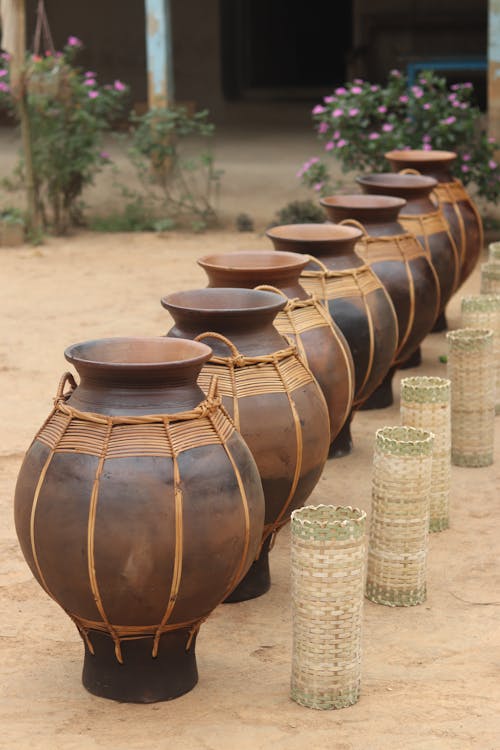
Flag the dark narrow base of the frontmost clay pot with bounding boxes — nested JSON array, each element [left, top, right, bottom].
[[82, 628, 198, 703]]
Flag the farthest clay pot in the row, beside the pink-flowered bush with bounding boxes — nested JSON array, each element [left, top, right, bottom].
[[385, 150, 484, 284]]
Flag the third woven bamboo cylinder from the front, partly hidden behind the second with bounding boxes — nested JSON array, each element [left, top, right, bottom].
[[401, 376, 451, 531]]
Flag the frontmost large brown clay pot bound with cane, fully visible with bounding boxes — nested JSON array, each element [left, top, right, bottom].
[[15, 338, 264, 703]]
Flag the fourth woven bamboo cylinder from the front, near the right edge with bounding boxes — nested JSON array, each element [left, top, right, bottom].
[[446, 328, 495, 467]]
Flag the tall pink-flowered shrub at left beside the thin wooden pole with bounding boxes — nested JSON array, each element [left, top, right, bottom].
[[0, 36, 127, 234]]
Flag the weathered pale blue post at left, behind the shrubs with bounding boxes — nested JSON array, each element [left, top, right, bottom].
[[145, 0, 174, 109]]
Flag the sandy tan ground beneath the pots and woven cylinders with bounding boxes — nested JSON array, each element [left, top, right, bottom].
[[0, 232, 500, 750]]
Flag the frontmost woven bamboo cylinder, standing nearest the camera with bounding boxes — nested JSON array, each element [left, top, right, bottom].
[[291, 505, 366, 709]]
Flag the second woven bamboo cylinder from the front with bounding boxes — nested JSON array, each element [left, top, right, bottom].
[[366, 427, 434, 607]]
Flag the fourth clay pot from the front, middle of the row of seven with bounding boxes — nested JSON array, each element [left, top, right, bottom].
[[267, 224, 398, 453]]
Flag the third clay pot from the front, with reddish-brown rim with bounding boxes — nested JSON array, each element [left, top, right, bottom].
[[198, 250, 354, 450]]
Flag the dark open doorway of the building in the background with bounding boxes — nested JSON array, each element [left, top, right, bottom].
[[221, 0, 352, 99]]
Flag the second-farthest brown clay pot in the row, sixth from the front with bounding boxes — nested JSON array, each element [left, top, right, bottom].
[[358, 172, 460, 331]]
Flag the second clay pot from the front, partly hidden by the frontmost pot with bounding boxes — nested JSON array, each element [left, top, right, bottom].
[[162, 288, 330, 601]]
